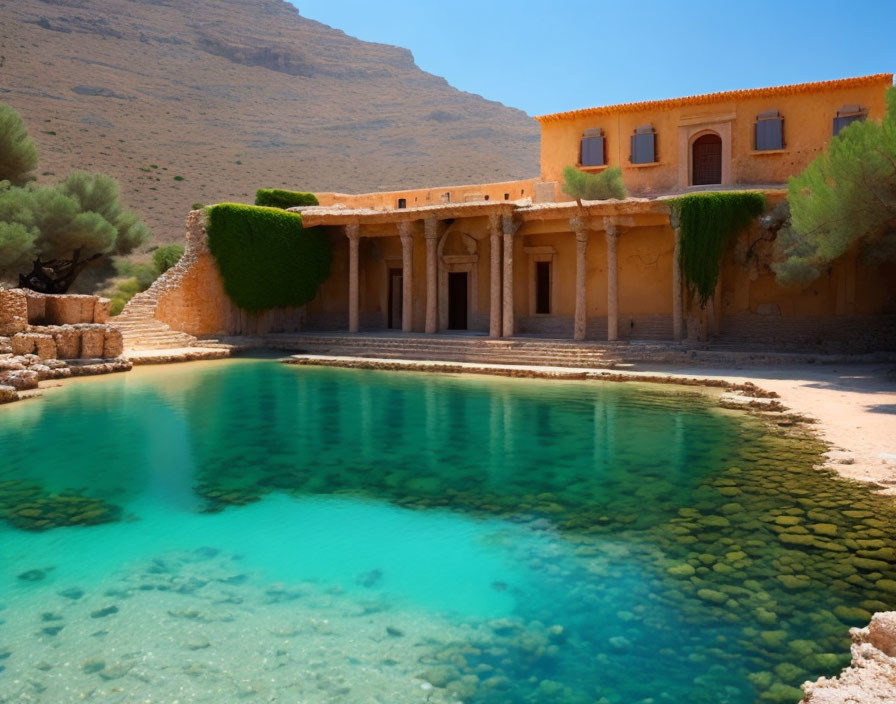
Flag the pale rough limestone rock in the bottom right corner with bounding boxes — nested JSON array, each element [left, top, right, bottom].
[[801, 611, 896, 704]]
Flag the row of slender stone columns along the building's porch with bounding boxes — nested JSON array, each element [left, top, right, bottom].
[[345, 214, 683, 340]]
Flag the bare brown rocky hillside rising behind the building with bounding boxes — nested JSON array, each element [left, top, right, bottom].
[[0, 0, 538, 242]]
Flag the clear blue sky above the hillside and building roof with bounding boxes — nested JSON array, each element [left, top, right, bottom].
[[291, 0, 896, 115]]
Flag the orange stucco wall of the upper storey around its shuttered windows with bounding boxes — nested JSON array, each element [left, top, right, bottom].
[[539, 74, 892, 200]]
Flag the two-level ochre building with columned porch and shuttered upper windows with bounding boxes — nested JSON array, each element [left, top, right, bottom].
[[149, 74, 896, 347]]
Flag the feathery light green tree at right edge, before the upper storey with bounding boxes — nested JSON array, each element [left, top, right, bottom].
[[772, 88, 896, 284]]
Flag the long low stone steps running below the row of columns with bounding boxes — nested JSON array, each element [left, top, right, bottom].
[[213, 334, 632, 369]]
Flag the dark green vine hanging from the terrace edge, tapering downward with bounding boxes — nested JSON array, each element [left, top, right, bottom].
[[670, 191, 765, 306]]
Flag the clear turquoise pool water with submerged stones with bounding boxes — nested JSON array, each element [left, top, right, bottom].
[[0, 359, 896, 704]]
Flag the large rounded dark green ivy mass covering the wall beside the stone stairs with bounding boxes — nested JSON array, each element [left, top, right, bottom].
[[207, 203, 332, 311]]
